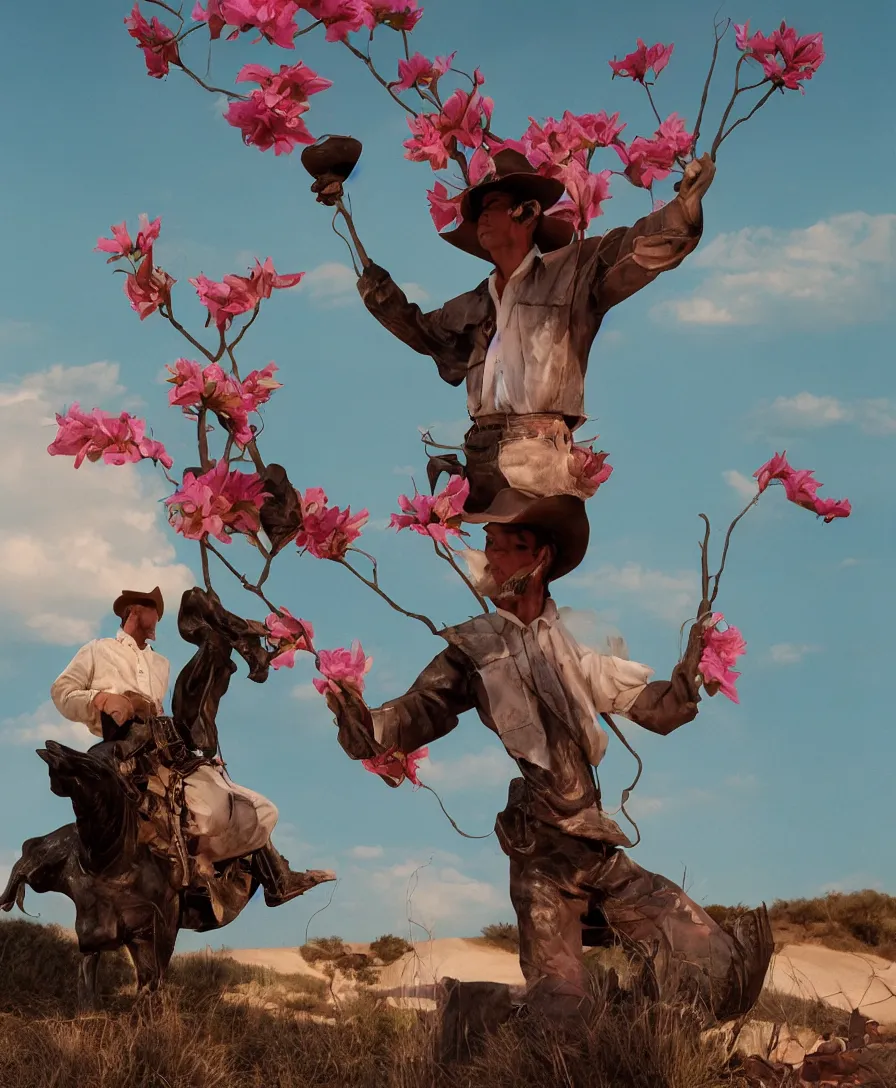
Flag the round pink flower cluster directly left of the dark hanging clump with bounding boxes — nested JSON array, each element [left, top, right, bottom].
[[165, 459, 267, 544]]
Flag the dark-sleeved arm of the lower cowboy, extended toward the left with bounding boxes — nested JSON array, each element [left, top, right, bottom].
[[329, 646, 475, 759]]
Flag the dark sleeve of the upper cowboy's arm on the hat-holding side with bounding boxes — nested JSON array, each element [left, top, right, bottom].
[[358, 264, 490, 385]]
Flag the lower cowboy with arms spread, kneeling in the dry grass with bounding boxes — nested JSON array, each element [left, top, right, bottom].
[[329, 496, 773, 1019]]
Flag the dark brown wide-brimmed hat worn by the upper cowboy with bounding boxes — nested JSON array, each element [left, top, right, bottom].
[[441, 148, 575, 261]]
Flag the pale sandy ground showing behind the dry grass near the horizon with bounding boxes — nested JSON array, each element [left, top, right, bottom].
[[226, 937, 896, 1024]]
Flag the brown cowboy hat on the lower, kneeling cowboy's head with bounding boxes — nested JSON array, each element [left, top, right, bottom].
[[462, 487, 590, 581]]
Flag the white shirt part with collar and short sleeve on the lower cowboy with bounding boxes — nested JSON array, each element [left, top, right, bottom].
[[497, 598, 654, 766]]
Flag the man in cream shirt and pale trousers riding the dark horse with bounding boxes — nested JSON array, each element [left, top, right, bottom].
[[50, 586, 335, 906]]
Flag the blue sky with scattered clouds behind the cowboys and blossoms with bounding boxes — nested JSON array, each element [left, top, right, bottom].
[[0, 0, 896, 948]]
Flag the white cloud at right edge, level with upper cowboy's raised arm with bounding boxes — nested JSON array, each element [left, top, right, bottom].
[[655, 211, 896, 325]]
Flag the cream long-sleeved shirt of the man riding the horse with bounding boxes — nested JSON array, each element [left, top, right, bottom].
[[50, 631, 171, 737]]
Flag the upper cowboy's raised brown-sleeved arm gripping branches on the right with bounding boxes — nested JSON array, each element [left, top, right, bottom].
[[592, 156, 715, 313]]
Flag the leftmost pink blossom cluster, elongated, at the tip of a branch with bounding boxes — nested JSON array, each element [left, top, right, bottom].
[[47, 403, 173, 469]]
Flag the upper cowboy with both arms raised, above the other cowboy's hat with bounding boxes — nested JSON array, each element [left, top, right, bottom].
[[358, 149, 715, 521]]
